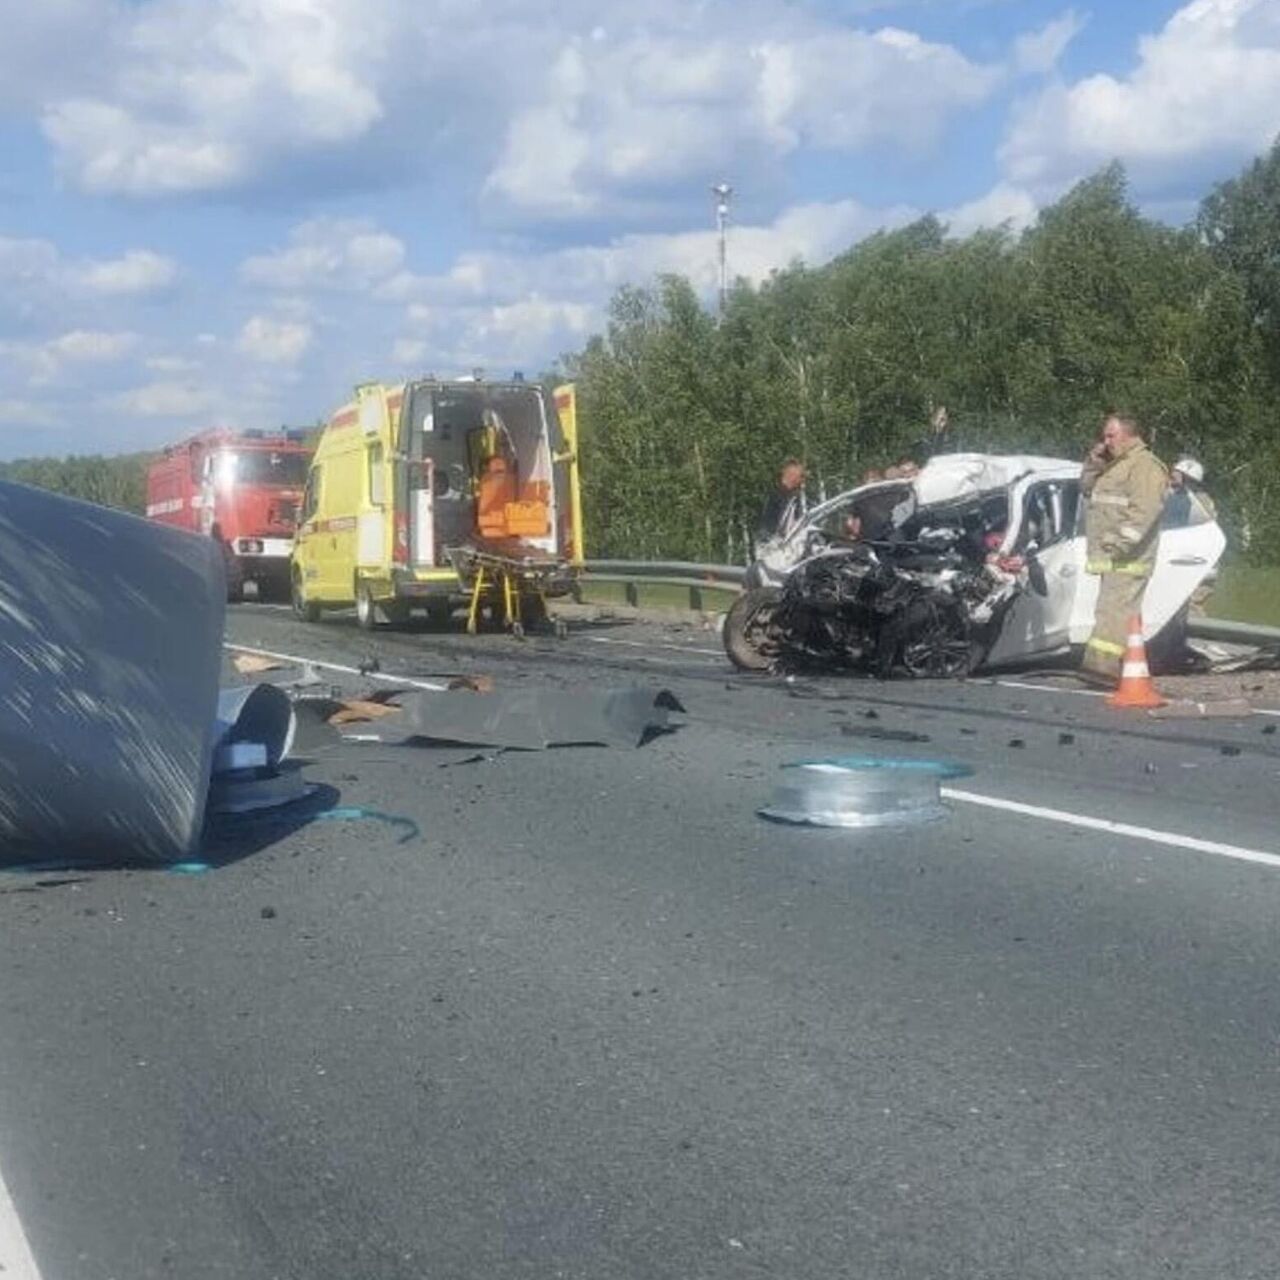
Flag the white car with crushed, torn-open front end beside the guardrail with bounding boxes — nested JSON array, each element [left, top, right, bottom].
[[723, 453, 1226, 677]]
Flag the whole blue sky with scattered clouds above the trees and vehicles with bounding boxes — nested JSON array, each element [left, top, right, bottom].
[[0, 0, 1280, 458]]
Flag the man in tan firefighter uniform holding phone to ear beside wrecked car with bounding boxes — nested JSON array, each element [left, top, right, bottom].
[[1080, 415, 1169, 681]]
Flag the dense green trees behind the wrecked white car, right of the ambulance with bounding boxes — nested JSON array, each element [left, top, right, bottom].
[[563, 142, 1280, 563]]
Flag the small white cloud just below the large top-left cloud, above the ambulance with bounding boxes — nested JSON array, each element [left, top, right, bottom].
[[239, 218, 404, 291]]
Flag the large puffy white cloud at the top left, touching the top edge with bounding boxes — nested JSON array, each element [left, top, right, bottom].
[[44, 0, 394, 196]]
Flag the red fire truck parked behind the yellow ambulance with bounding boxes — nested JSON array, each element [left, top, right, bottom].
[[147, 430, 312, 600]]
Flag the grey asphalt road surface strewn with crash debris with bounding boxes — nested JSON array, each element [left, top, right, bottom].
[[0, 607, 1280, 1280]]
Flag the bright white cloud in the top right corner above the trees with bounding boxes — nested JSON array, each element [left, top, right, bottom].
[[1001, 0, 1280, 189]]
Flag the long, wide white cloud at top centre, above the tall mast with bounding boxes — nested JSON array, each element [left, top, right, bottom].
[[486, 20, 1002, 216]]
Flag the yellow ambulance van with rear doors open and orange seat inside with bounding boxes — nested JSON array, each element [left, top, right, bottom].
[[289, 378, 582, 628]]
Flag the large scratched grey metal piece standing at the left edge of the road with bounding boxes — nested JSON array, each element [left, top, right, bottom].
[[0, 481, 227, 865]]
